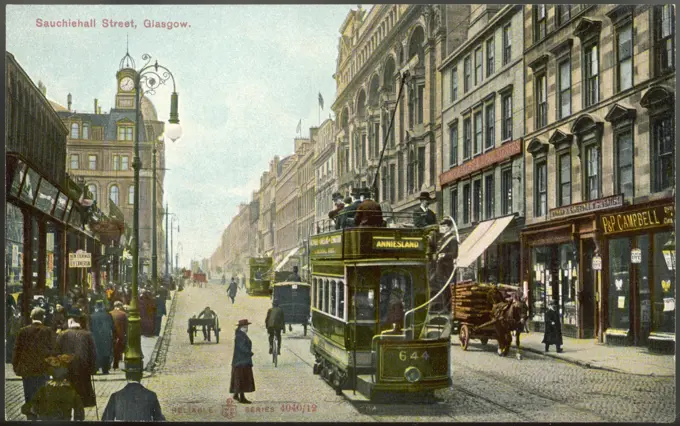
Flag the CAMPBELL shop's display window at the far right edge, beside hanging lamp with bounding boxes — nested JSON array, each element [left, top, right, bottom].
[[652, 232, 677, 334]]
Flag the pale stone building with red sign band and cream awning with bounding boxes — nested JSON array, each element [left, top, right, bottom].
[[439, 4, 524, 286]]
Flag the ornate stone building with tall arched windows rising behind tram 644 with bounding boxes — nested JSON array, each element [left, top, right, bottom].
[[331, 4, 470, 216]]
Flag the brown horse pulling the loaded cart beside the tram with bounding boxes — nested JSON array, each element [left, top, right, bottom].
[[493, 294, 529, 360]]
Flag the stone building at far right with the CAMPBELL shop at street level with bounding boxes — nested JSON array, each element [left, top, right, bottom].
[[521, 5, 676, 345]]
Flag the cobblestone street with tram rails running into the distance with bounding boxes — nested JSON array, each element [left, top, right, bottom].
[[5, 283, 675, 422]]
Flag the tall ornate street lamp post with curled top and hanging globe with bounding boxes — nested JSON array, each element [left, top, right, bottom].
[[125, 53, 182, 381]]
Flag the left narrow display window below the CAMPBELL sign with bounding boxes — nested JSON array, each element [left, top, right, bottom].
[[609, 237, 631, 330]]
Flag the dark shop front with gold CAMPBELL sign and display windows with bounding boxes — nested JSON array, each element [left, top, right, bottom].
[[598, 200, 676, 349]]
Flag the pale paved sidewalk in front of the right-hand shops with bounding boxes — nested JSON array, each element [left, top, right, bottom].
[[452, 332, 675, 377]]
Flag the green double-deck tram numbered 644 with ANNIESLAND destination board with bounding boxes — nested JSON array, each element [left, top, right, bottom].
[[310, 216, 451, 399]]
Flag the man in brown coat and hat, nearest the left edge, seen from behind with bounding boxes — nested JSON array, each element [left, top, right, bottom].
[[12, 308, 57, 412]]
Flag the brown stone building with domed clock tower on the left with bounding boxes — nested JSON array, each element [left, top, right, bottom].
[[53, 53, 165, 276]]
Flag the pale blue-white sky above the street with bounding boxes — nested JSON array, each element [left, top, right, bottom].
[[6, 4, 362, 267]]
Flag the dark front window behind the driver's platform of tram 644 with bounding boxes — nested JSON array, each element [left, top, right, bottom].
[[380, 271, 413, 330]]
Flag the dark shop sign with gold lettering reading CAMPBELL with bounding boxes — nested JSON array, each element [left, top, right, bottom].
[[601, 205, 675, 235]]
